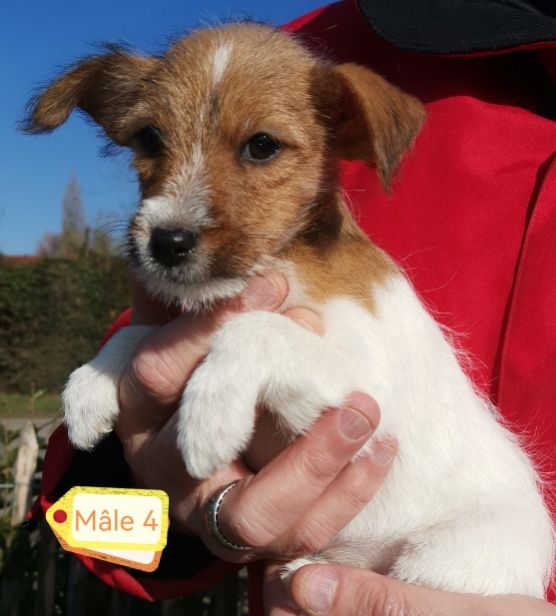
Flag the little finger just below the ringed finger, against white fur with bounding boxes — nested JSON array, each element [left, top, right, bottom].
[[280, 435, 397, 556]]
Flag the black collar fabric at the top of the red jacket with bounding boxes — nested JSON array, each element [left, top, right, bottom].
[[357, 0, 556, 54]]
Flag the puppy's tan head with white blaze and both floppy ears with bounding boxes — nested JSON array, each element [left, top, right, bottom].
[[27, 24, 423, 307]]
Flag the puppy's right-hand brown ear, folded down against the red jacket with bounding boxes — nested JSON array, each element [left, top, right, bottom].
[[317, 64, 425, 189]]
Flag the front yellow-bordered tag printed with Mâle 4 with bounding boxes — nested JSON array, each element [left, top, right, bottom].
[[46, 486, 168, 556]]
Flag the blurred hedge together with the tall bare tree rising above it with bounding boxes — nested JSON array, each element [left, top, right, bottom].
[[0, 175, 129, 394]]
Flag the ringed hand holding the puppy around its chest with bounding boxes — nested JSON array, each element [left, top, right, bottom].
[[116, 273, 394, 562]]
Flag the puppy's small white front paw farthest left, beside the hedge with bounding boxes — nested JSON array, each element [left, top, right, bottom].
[[62, 362, 118, 450]]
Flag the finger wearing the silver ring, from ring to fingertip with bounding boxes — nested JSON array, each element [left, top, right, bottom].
[[216, 393, 379, 547]]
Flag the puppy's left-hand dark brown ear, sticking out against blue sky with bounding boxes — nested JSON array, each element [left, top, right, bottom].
[[22, 48, 157, 143]]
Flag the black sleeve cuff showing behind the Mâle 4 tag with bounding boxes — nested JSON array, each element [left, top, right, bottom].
[[59, 433, 215, 579]]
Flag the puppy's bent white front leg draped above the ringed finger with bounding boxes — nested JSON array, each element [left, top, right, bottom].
[[178, 312, 357, 479]]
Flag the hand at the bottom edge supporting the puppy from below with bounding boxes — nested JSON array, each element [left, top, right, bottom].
[[286, 565, 556, 616]]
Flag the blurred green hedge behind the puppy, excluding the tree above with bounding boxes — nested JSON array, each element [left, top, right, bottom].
[[0, 258, 129, 393]]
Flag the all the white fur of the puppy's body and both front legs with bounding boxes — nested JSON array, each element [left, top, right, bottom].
[[64, 275, 554, 597]]
